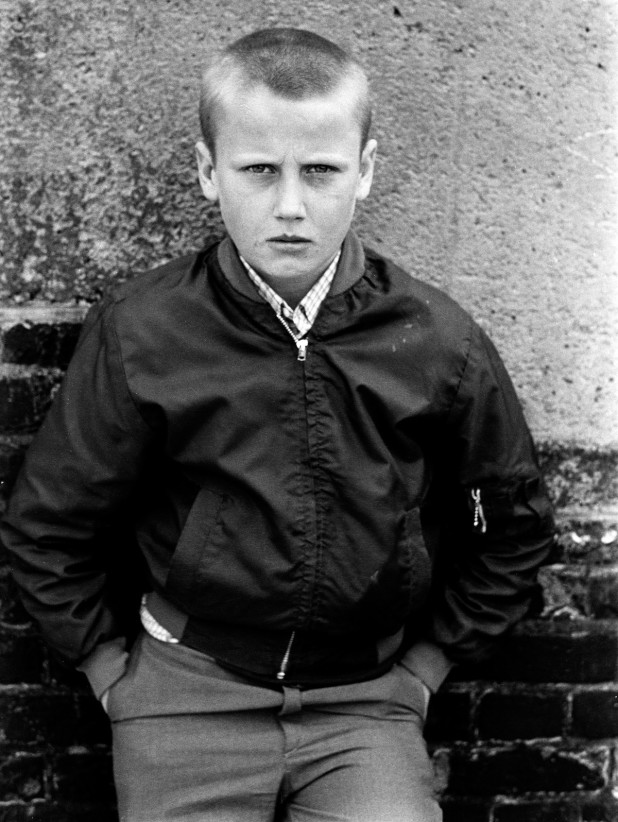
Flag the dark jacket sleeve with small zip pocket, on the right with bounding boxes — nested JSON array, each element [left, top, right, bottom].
[[413, 324, 554, 670]]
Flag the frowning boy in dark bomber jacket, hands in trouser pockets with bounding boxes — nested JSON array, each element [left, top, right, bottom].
[[3, 29, 552, 822]]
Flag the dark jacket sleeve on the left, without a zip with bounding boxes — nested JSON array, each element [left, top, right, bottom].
[[1, 302, 153, 664]]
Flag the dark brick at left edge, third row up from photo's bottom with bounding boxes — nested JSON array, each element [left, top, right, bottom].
[[0, 691, 78, 745]]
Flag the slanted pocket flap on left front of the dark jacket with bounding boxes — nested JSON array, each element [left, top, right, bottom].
[[165, 488, 228, 597]]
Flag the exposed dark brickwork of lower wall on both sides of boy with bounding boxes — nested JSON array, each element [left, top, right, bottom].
[[0, 304, 618, 822]]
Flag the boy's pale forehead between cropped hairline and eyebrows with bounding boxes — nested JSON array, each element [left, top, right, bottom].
[[216, 81, 361, 152]]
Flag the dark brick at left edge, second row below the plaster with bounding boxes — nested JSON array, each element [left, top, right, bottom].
[[0, 365, 61, 434]]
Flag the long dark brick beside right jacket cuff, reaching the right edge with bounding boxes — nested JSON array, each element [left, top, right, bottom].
[[455, 619, 618, 683]]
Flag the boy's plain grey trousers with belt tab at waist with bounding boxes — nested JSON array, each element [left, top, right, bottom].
[[108, 634, 442, 822]]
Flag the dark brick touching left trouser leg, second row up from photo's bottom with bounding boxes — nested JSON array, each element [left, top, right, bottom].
[[52, 750, 115, 807]]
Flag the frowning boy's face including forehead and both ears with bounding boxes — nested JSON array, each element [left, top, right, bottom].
[[196, 83, 376, 296]]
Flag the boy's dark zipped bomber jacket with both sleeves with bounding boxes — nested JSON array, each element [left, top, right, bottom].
[[2, 234, 552, 691]]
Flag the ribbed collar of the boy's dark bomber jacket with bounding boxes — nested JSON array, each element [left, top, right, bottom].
[[217, 231, 365, 303]]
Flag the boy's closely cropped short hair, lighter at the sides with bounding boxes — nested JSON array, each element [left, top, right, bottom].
[[200, 28, 371, 160]]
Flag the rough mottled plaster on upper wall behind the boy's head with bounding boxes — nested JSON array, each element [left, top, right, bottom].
[[0, 0, 618, 447]]
